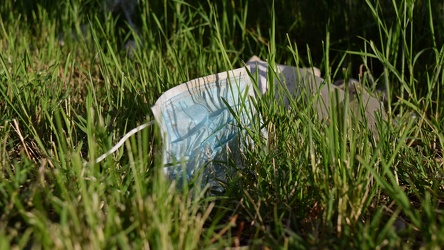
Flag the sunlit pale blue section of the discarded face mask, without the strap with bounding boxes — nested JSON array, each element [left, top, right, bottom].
[[152, 68, 255, 186]]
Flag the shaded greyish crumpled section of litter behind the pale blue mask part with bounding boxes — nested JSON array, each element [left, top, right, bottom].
[[247, 56, 387, 140]]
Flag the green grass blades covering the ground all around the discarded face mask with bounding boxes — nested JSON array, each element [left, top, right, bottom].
[[0, 0, 444, 249]]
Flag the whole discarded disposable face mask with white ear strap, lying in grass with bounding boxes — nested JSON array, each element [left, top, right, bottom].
[[96, 57, 385, 187]]
